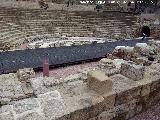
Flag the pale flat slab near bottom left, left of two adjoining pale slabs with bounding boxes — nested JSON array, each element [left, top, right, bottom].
[[13, 98, 39, 114]]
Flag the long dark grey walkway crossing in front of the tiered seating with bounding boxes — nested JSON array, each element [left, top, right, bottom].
[[0, 40, 146, 74]]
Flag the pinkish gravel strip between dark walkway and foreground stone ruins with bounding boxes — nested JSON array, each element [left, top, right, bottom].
[[36, 62, 98, 78]]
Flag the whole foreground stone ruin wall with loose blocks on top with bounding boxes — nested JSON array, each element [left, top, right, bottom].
[[0, 40, 160, 120]]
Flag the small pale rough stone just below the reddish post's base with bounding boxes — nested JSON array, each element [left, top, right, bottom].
[[43, 77, 63, 87]]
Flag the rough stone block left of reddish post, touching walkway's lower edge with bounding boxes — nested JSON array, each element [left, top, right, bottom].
[[17, 68, 35, 81]]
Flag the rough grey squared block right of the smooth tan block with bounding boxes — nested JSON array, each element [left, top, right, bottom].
[[120, 62, 145, 81]]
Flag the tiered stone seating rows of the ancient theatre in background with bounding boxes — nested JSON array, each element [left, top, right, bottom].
[[0, 8, 137, 49]]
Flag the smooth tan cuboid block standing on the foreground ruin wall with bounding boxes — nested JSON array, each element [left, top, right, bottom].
[[87, 70, 112, 94]]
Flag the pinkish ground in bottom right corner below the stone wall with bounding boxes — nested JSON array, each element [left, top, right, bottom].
[[130, 102, 160, 120]]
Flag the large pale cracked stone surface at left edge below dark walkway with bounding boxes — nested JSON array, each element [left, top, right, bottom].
[[0, 73, 26, 105]]
